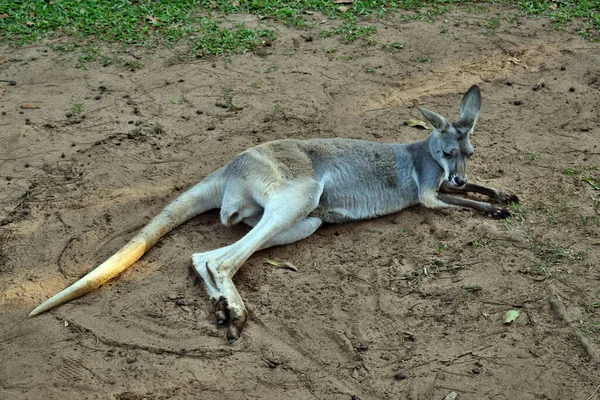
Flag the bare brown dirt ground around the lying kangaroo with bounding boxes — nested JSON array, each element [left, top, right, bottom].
[[0, 8, 600, 400]]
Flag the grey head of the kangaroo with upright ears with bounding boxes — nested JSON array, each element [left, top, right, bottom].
[[418, 85, 481, 186]]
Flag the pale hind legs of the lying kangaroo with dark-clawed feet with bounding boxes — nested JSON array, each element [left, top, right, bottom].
[[192, 179, 323, 343]]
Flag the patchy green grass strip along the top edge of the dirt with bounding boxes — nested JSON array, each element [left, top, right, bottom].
[[0, 0, 600, 65]]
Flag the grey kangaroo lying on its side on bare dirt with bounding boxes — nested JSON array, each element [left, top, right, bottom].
[[29, 86, 518, 343]]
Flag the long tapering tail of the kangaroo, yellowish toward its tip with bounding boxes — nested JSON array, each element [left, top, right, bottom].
[[29, 168, 224, 318]]
